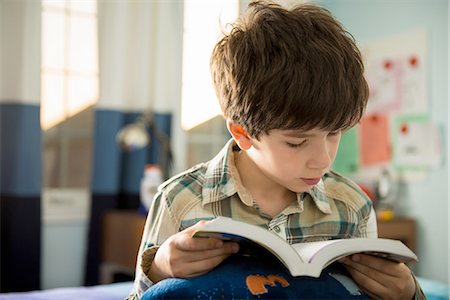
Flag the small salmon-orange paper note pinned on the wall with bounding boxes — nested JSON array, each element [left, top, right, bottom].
[[360, 114, 391, 166]]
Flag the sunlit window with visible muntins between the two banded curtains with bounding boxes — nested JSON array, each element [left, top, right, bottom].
[[41, 0, 99, 188]]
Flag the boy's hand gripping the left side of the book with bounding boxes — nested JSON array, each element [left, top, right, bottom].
[[148, 221, 239, 282]]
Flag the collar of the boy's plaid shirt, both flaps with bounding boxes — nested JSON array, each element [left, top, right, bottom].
[[202, 139, 331, 214]]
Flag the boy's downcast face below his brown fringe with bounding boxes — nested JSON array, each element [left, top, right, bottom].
[[246, 129, 341, 193]]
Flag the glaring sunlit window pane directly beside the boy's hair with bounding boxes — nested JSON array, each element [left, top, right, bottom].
[[181, 0, 239, 130]]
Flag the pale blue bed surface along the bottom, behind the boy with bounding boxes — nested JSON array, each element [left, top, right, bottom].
[[0, 277, 450, 300]]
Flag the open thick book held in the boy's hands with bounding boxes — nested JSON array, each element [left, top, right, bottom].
[[194, 217, 417, 277]]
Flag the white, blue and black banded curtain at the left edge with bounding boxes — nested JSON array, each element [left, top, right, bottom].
[[0, 0, 42, 292]]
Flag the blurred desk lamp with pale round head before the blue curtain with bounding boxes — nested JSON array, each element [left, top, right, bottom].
[[116, 111, 172, 179]]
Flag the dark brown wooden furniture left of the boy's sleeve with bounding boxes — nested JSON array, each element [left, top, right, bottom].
[[100, 210, 145, 284]]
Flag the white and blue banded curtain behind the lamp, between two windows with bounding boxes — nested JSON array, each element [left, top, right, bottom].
[[85, 0, 183, 285]]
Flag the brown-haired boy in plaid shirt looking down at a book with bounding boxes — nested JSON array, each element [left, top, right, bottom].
[[130, 2, 420, 299]]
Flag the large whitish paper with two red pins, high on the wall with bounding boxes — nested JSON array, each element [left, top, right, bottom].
[[362, 31, 428, 114]]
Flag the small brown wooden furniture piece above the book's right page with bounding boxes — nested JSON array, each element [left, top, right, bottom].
[[378, 218, 417, 252]]
